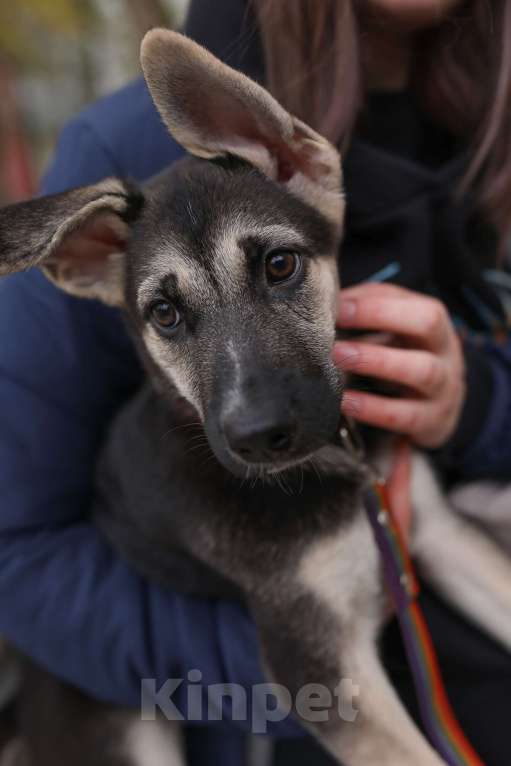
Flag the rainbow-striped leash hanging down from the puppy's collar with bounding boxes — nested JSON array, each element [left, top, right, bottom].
[[339, 421, 484, 766]]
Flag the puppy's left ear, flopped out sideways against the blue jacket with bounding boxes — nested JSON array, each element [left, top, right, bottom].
[[0, 178, 142, 305]]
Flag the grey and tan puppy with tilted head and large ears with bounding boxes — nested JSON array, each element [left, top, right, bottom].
[[0, 30, 511, 766]]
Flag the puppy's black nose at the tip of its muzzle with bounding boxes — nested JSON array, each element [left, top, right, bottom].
[[223, 414, 296, 463]]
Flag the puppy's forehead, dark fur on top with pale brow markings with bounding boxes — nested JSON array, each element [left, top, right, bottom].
[[132, 157, 337, 303]]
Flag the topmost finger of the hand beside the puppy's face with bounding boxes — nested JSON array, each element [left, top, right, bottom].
[[337, 285, 450, 351]]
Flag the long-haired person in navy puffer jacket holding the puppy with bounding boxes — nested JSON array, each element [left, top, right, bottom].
[[0, 0, 511, 766]]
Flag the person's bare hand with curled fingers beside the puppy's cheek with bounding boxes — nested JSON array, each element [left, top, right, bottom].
[[333, 284, 465, 448]]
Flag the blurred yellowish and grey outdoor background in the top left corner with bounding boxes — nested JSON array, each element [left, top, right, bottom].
[[0, 0, 188, 205]]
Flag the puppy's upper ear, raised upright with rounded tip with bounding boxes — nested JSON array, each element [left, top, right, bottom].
[[141, 29, 343, 228]]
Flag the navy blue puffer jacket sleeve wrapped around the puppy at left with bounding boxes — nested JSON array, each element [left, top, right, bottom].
[[0, 115, 297, 734]]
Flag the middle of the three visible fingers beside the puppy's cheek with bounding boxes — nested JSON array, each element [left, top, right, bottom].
[[333, 341, 448, 396]]
